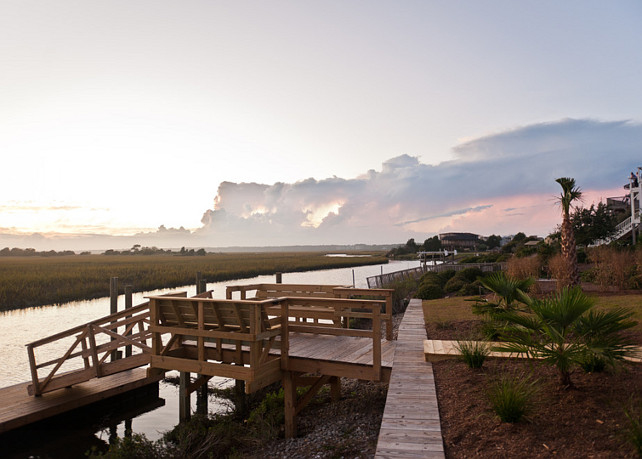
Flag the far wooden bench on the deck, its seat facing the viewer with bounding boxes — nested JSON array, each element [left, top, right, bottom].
[[225, 284, 394, 340]]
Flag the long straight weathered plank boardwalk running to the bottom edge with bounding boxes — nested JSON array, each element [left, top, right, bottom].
[[375, 300, 445, 459]]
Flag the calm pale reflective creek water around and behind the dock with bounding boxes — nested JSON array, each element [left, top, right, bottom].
[[0, 261, 419, 441]]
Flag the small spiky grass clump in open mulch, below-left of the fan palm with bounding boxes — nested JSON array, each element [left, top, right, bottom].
[[488, 375, 537, 422]]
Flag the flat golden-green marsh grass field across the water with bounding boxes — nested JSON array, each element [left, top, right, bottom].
[[0, 252, 387, 310]]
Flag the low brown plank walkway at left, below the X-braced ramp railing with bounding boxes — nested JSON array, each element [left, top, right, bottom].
[[0, 368, 160, 433]]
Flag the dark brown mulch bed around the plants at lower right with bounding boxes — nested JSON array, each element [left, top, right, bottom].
[[426, 321, 642, 458]]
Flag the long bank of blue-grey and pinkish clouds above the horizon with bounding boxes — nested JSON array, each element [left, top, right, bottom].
[[0, 119, 642, 249]]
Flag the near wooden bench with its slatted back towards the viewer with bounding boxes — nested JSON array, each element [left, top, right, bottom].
[[149, 296, 281, 392]]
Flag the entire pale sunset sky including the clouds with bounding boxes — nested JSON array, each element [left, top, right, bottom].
[[0, 0, 642, 250]]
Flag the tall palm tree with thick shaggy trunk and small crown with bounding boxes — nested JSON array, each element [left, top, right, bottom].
[[555, 177, 582, 287]]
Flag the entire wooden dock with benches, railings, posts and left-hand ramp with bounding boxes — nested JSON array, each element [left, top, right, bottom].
[[0, 285, 396, 437]]
